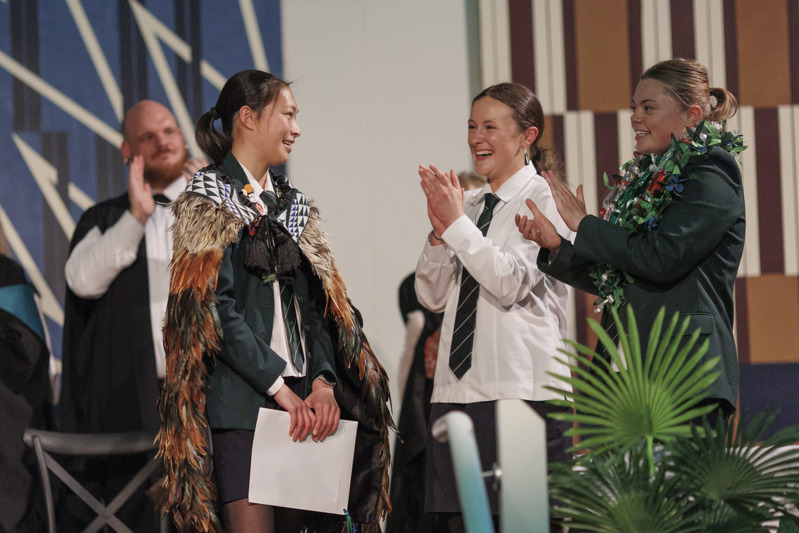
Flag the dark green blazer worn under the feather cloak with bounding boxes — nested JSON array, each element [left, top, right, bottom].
[[206, 153, 336, 430]]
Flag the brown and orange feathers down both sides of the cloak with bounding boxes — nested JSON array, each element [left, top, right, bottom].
[[151, 194, 396, 533]]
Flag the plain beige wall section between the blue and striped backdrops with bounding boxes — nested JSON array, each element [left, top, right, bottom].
[[281, 0, 472, 411]]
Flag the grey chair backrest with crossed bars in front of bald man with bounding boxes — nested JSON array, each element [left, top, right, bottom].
[[23, 429, 165, 533]]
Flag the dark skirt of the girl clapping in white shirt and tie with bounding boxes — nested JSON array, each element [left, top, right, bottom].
[[425, 401, 572, 515]]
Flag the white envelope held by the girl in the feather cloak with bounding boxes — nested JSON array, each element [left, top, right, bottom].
[[250, 408, 358, 514]]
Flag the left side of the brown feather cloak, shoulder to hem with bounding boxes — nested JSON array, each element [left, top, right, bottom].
[[151, 194, 239, 533]]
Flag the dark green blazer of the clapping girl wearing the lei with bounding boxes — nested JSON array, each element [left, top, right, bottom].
[[538, 147, 746, 408]]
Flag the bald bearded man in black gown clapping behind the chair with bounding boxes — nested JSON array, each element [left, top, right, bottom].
[[57, 100, 206, 532]]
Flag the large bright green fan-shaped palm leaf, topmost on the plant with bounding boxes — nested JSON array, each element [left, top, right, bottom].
[[553, 306, 718, 453]]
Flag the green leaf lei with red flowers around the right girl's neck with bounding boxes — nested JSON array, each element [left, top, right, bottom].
[[591, 121, 746, 311]]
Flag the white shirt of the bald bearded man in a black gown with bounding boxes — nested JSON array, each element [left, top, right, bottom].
[[64, 176, 187, 378]]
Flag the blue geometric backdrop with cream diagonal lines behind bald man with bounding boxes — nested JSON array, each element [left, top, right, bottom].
[[0, 0, 283, 357]]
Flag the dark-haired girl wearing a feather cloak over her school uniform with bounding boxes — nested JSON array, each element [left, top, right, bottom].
[[153, 70, 393, 532]]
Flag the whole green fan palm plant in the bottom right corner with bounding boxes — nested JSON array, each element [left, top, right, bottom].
[[550, 308, 799, 533]]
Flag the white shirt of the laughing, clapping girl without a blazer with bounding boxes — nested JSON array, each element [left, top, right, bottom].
[[416, 164, 574, 403]]
